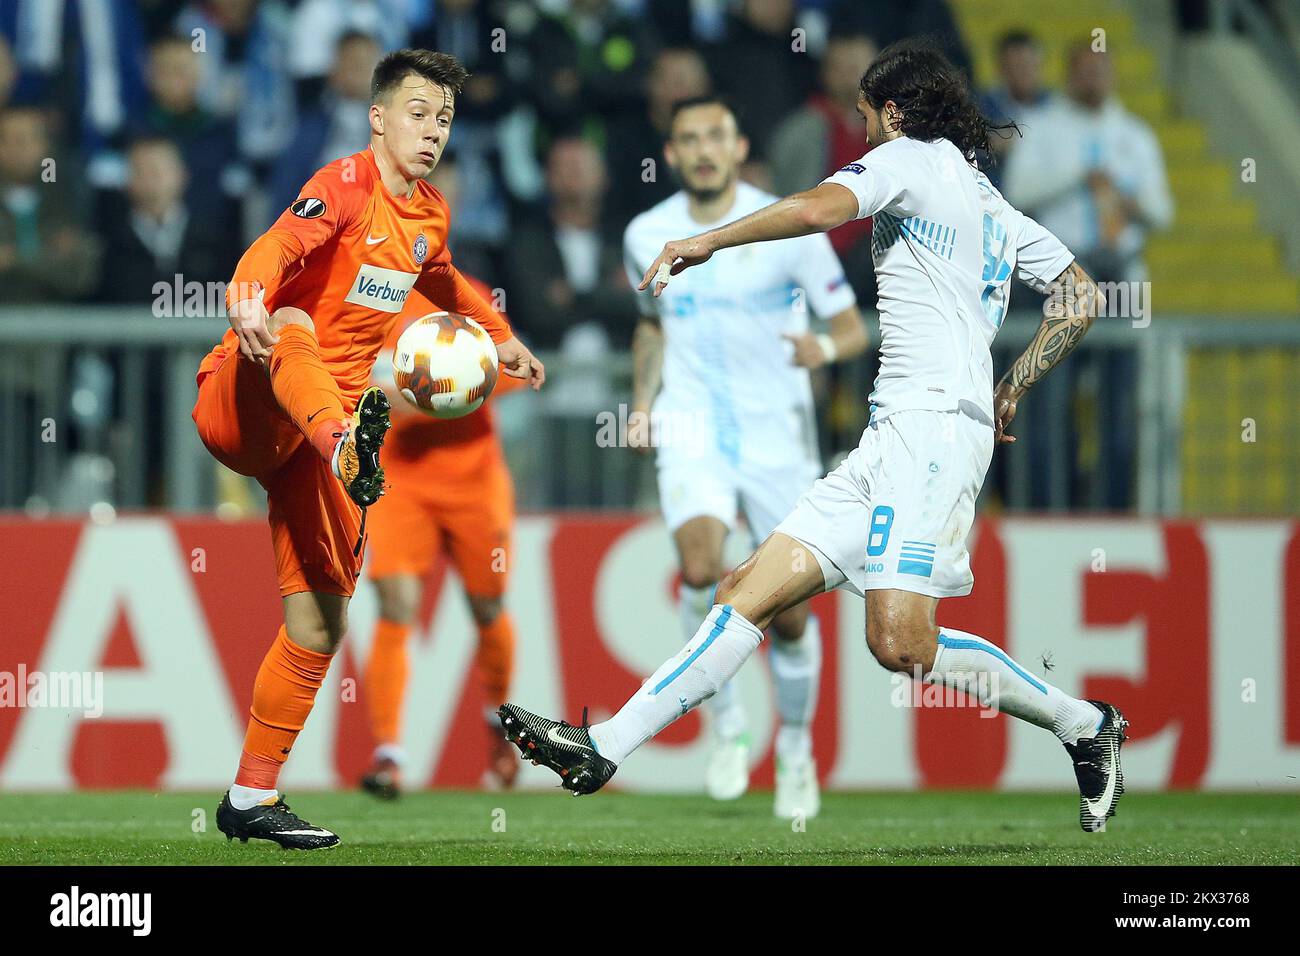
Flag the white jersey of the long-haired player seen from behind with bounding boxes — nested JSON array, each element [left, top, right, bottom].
[[826, 137, 1074, 424]]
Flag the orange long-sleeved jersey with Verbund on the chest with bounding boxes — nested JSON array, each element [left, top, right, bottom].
[[199, 148, 514, 406]]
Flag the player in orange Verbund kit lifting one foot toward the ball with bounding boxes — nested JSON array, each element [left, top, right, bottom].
[[194, 49, 545, 849]]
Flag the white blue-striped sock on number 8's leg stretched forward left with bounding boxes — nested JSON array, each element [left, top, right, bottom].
[[590, 605, 763, 763]]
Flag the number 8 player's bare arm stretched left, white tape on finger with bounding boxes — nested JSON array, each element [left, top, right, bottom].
[[637, 182, 858, 295]]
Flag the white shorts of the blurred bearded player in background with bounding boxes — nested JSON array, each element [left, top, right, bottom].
[[657, 449, 822, 545]]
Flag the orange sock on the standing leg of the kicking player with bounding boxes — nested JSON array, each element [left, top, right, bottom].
[[235, 626, 333, 790]]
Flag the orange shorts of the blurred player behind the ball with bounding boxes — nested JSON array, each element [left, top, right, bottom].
[[365, 457, 515, 597]]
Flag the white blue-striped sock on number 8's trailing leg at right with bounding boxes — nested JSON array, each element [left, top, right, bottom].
[[926, 627, 1102, 744]]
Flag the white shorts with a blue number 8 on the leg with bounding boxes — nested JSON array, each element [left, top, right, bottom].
[[776, 410, 993, 597]]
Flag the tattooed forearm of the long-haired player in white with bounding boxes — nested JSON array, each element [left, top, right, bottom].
[[993, 261, 1105, 442]]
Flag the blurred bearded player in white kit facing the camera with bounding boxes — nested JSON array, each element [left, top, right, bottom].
[[624, 96, 867, 817]]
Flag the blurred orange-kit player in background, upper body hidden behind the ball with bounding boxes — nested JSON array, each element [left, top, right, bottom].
[[361, 270, 521, 800]]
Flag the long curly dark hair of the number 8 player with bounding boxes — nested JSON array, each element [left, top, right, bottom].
[[858, 39, 1019, 160]]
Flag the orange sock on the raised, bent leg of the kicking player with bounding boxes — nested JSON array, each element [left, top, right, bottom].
[[270, 325, 347, 462]]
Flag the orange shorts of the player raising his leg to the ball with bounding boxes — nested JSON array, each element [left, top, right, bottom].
[[194, 352, 363, 597]]
